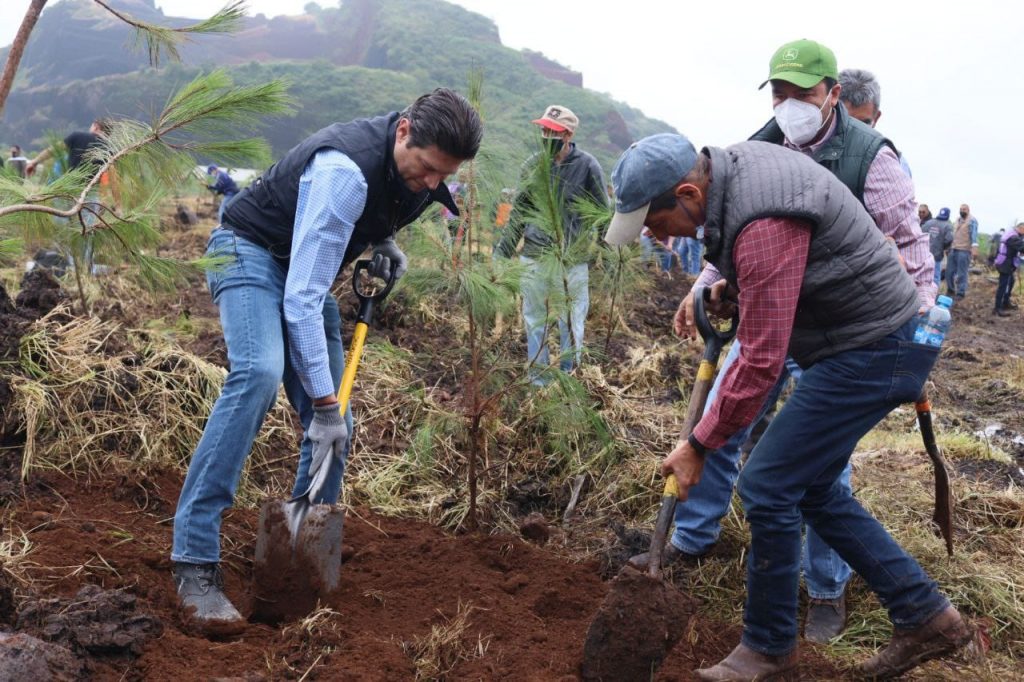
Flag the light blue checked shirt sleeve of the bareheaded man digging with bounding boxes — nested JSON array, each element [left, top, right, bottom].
[[284, 150, 367, 399]]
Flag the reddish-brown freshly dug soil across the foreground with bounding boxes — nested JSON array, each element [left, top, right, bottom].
[[0, 458, 841, 682]]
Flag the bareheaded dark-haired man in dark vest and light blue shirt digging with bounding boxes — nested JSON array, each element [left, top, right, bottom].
[[171, 88, 482, 635]]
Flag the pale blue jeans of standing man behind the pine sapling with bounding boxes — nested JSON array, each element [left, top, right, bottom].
[[519, 256, 590, 383]]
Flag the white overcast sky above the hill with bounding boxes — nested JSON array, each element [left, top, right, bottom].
[[0, 0, 1024, 232]]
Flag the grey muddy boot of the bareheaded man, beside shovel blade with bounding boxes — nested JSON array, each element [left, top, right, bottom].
[[174, 561, 246, 637]]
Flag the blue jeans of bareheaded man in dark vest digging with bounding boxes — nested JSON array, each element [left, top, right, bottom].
[[171, 228, 352, 563]]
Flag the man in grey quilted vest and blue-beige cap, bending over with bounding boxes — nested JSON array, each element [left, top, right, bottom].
[[605, 134, 971, 681]]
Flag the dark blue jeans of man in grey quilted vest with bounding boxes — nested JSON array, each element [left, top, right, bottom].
[[736, 317, 949, 655]]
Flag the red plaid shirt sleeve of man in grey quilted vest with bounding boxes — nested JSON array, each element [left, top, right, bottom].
[[693, 218, 811, 450]]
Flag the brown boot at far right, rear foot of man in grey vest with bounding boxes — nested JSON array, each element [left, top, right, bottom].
[[857, 606, 973, 680]]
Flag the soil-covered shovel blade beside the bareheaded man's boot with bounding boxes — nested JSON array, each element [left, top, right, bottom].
[[252, 493, 345, 625]]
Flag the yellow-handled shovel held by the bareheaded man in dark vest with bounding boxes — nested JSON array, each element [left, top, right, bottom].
[[252, 254, 394, 624]]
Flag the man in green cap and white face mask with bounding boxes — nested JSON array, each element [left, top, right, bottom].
[[647, 40, 936, 642]]
